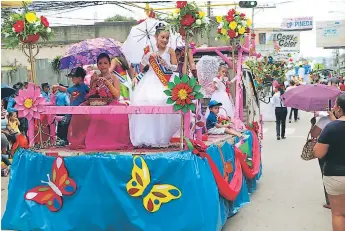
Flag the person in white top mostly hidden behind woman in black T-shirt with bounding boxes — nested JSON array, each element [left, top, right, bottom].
[[310, 111, 336, 209]]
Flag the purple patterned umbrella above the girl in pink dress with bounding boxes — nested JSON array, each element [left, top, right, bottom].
[[60, 38, 122, 69]]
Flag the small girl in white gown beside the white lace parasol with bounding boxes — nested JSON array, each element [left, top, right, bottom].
[[205, 64, 235, 119]]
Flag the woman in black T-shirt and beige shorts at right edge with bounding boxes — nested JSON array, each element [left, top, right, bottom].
[[314, 94, 345, 231]]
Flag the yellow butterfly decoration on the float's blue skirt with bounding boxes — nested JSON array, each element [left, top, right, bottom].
[[126, 156, 182, 213]]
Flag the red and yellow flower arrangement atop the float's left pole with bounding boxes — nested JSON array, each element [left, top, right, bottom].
[[1, 3, 52, 48]]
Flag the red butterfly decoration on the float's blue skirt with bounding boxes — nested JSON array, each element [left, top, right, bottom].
[[24, 157, 77, 212]]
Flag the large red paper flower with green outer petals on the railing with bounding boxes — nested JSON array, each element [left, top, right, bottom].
[[164, 75, 204, 113]]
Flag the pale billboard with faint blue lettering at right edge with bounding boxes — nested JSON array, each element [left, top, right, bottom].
[[316, 20, 345, 48]]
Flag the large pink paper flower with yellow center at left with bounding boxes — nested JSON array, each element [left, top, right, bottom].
[[14, 83, 45, 121]]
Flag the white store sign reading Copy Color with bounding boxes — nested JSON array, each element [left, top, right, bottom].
[[266, 31, 300, 52]]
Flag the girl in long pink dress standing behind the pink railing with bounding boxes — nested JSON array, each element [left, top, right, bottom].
[[68, 53, 132, 151]]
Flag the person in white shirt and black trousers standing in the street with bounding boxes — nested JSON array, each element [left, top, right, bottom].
[[272, 86, 287, 140]]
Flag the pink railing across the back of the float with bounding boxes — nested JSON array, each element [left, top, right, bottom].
[[28, 105, 191, 146]]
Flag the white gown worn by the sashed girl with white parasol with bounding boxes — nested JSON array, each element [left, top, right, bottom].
[[129, 48, 181, 147]]
